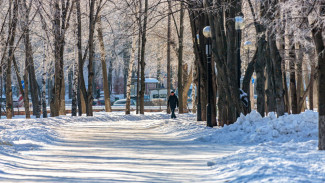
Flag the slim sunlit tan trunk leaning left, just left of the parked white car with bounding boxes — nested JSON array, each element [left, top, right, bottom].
[[97, 15, 112, 112]]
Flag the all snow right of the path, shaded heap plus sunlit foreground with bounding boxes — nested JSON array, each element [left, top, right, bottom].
[[195, 111, 325, 182]]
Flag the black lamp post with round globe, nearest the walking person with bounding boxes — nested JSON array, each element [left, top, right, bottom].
[[203, 26, 213, 127]]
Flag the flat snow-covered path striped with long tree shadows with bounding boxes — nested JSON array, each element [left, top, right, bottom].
[[0, 115, 236, 182]]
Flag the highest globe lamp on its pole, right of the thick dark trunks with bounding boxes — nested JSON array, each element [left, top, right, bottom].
[[235, 16, 244, 88]]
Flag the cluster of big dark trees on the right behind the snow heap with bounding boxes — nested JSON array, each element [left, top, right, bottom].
[[187, 0, 325, 149]]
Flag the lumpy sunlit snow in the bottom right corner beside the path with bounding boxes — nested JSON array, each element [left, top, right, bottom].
[[210, 140, 325, 183]]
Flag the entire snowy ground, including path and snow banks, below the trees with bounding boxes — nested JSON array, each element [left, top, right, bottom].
[[0, 111, 325, 182]]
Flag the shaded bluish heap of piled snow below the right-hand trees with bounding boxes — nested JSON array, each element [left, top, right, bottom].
[[197, 111, 318, 144]]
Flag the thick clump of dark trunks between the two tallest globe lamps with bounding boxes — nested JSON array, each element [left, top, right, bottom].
[[204, 0, 243, 123]]
